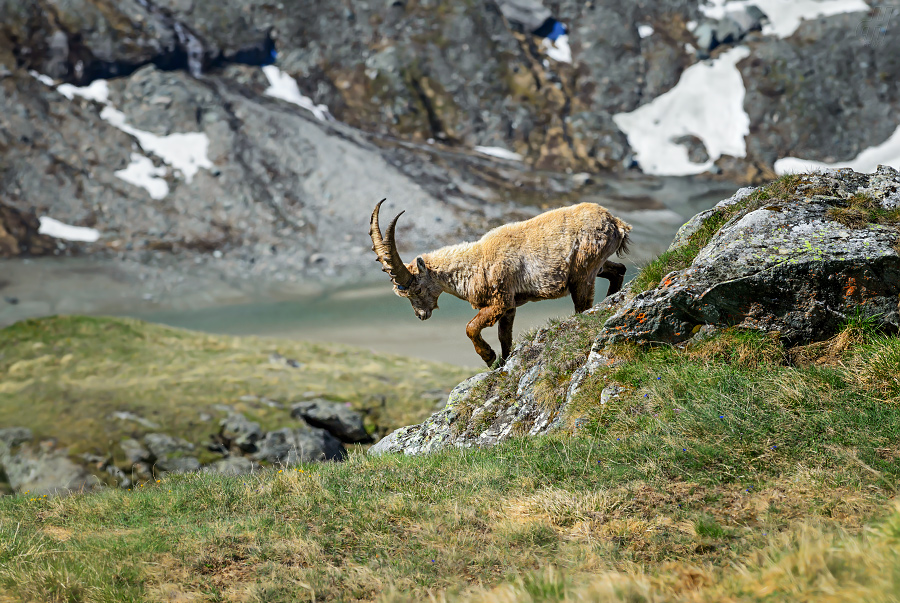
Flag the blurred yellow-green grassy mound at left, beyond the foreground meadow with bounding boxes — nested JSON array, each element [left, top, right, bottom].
[[0, 317, 472, 460]]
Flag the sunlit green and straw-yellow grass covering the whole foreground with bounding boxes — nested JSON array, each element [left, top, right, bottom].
[[0, 317, 900, 601]]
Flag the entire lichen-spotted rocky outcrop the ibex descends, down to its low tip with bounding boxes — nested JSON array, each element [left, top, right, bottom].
[[369, 167, 900, 454]]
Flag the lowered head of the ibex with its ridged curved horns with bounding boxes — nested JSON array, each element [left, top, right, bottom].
[[369, 199, 442, 320]]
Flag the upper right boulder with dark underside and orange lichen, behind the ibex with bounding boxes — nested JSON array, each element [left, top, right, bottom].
[[595, 167, 900, 347]]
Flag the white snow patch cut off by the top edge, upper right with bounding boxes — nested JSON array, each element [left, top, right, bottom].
[[700, 0, 869, 38]]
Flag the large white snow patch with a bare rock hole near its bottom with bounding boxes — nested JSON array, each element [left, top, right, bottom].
[[613, 46, 750, 176]]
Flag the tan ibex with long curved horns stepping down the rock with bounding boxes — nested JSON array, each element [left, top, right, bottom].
[[369, 199, 631, 366]]
